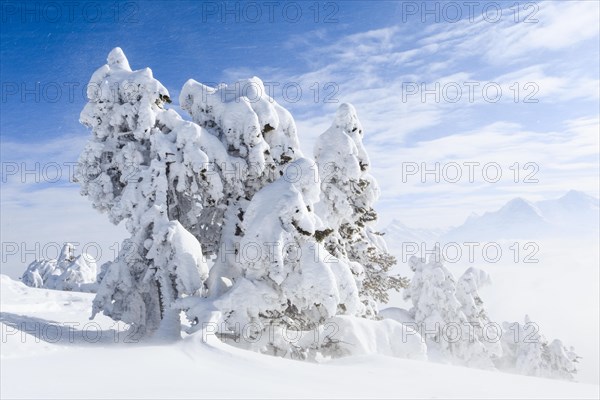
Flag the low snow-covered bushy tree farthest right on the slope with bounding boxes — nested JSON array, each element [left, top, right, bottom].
[[496, 315, 580, 380]]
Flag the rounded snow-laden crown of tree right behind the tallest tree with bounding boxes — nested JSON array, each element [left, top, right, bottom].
[[179, 77, 302, 183]]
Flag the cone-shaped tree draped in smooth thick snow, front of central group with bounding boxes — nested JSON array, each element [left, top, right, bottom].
[[185, 158, 362, 355]]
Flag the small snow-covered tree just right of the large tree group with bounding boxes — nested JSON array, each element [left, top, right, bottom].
[[405, 250, 493, 368]]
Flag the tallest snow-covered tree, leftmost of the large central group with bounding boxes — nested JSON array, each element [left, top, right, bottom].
[[77, 48, 212, 334]]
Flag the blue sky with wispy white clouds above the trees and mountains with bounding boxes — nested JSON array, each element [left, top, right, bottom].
[[0, 1, 600, 274]]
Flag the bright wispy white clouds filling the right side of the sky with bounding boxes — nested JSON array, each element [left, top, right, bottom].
[[251, 2, 600, 226]]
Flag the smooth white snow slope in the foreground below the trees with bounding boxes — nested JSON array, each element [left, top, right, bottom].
[[0, 276, 600, 398]]
